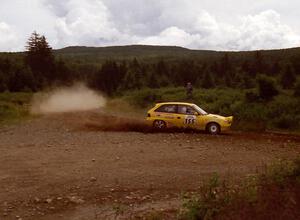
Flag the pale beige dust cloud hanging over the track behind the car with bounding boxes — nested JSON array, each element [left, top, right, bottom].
[[31, 84, 106, 114]]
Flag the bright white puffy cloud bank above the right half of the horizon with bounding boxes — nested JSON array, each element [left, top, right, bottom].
[[140, 10, 300, 50]]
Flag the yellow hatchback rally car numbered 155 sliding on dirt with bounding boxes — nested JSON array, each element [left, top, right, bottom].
[[146, 102, 233, 134]]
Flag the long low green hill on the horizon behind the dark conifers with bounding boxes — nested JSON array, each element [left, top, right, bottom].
[[54, 45, 300, 64]]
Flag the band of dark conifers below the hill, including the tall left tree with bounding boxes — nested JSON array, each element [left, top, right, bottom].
[[0, 32, 300, 96]]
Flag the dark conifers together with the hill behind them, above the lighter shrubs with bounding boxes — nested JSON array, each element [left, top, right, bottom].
[[0, 33, 300, 95]]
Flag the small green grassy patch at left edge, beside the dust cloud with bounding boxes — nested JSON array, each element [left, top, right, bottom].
[[0, 93, 32, 126]]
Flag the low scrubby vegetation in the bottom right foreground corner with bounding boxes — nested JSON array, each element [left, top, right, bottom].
[[178, 158, 300, 220]]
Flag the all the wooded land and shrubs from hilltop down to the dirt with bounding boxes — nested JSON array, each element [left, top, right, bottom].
[[0, 32, 300, 129]]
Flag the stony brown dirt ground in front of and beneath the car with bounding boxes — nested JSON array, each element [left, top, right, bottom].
[[0, 112, 300, 220]]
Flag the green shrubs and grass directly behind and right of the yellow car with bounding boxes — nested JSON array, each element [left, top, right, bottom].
[[118, 87, 300, 131]]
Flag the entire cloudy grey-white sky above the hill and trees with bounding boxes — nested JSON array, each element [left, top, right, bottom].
[[0, 0, 300, 51]]
